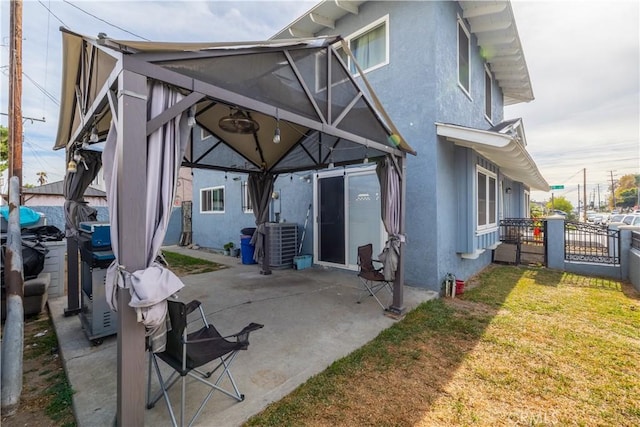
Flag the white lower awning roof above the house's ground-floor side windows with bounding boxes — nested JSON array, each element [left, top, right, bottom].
[[436, 119, 549, 191]]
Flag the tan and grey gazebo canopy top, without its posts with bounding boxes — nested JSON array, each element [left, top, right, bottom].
[[54, 29, 415, 175]]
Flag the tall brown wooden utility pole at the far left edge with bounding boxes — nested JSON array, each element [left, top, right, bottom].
[[8, 0, 22, 191]]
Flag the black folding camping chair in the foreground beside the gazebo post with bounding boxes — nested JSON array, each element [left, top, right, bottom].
[[147, 300, 263, 426]]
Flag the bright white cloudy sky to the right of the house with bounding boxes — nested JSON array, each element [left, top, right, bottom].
[[505, 1, 640, 205]]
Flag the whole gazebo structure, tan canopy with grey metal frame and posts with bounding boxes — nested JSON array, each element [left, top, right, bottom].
[[54, 29, 415, 425]]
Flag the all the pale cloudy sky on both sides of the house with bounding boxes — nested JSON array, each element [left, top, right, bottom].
[[0, 0, 640, 205]]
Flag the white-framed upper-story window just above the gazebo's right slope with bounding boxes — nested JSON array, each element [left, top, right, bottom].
[[336, 15, 389, 75]]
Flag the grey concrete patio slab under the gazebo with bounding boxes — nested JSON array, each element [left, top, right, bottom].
[[49, 246, 437, 427]]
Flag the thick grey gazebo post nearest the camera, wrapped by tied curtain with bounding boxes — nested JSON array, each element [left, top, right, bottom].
[[116, 70, 147, 427]]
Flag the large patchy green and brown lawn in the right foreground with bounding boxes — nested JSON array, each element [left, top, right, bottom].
[[247, 266, 640, 426]]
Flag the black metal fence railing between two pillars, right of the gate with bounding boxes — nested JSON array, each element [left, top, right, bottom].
[[564, 221, 620, 265]]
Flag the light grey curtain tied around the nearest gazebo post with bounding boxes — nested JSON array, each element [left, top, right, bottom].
[[103, 82, 189, 351]]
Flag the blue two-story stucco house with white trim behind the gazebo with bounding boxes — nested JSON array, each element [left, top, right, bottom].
[[188, 0, 548, 290]]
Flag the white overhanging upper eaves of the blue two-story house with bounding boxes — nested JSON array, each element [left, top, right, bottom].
[[272, 0, 534, 105]]
